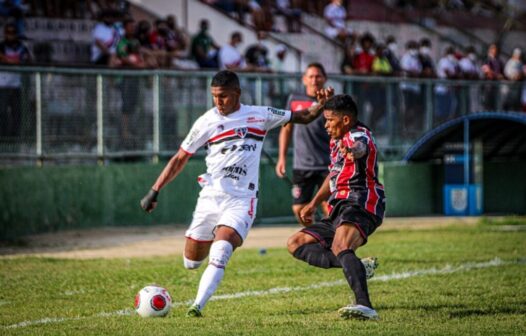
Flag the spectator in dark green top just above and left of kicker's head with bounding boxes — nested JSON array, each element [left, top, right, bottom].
[[190, 19, 220, 69]]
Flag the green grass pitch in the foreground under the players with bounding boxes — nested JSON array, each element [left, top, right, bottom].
[[0, 218, 526, 335]]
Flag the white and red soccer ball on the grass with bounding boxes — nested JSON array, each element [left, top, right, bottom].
[[135, 285, 172, 317]]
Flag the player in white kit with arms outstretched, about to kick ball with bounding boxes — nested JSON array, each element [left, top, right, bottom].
[[141, 70, 334, 317]]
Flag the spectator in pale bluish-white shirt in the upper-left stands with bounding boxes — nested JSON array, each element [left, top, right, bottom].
[[91, 11, 119, 65]]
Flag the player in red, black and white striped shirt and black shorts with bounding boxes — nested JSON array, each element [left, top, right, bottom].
[[287, 95, 385, 319]]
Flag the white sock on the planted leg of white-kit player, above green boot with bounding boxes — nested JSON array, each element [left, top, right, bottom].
[[194, 240, 234, 309]]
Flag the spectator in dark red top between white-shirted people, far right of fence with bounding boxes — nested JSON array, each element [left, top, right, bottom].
[[481, 44, 504, 111]]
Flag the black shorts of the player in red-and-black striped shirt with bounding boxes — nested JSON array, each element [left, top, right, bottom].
[[301, 200, 382, 248]]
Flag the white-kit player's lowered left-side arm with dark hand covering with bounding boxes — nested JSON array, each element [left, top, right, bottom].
[[141, 149, 192, 212]]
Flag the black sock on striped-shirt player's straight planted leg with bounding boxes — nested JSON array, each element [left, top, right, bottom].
[[338, 250, 373, 308]]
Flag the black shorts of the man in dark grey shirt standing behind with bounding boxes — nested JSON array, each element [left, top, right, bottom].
[[292, 169, 329, 204]]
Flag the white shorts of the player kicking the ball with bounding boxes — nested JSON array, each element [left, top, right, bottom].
[[185, 188, 258, 242]]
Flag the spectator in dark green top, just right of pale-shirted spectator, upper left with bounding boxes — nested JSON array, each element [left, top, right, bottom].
[[117, 19, 146, 142]]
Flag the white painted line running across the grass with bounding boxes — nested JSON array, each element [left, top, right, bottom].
[[3, 258, 526, 329]]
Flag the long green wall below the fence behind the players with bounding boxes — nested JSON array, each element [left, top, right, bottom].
[[0, 158, 526, 240]]
